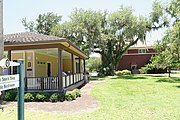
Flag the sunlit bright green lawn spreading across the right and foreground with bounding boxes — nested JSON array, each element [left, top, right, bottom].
[[0, 75, 180, 120]]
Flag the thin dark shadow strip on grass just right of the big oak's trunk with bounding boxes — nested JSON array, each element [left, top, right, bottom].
[[112, 75, 147, 80]]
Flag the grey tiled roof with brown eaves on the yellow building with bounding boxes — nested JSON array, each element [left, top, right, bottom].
[[3, 32, 88, 59]]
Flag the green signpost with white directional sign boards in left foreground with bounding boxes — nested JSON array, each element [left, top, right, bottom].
[[0, 59, 24, 120]]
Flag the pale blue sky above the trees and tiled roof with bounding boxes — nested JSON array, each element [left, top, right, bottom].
[[3, 0, 169, 43]]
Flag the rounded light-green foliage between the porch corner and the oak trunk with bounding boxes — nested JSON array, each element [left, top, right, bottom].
[[86, 57, 101, 72]]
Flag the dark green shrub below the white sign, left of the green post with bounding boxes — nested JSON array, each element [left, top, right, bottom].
[[4, 90, 16, 101]]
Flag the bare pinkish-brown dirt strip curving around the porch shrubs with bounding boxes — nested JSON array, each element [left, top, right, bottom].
[[3, 81, 102, 113]]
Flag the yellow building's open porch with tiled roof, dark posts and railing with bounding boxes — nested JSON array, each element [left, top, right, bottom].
[[4, 32, 88, 92]]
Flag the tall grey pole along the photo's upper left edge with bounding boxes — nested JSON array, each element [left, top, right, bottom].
[[0, 0, 4, 75]]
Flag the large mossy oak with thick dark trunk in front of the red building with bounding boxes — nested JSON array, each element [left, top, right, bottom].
[[97, 1, 168, 75]]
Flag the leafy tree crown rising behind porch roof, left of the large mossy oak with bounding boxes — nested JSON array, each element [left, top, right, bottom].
[[51, 9, 103, 54]]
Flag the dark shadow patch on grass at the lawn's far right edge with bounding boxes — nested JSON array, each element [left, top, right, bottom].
[[156, 77, 180, 83]]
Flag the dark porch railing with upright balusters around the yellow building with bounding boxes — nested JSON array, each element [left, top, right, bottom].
[[25, 73, 85, 91]]
